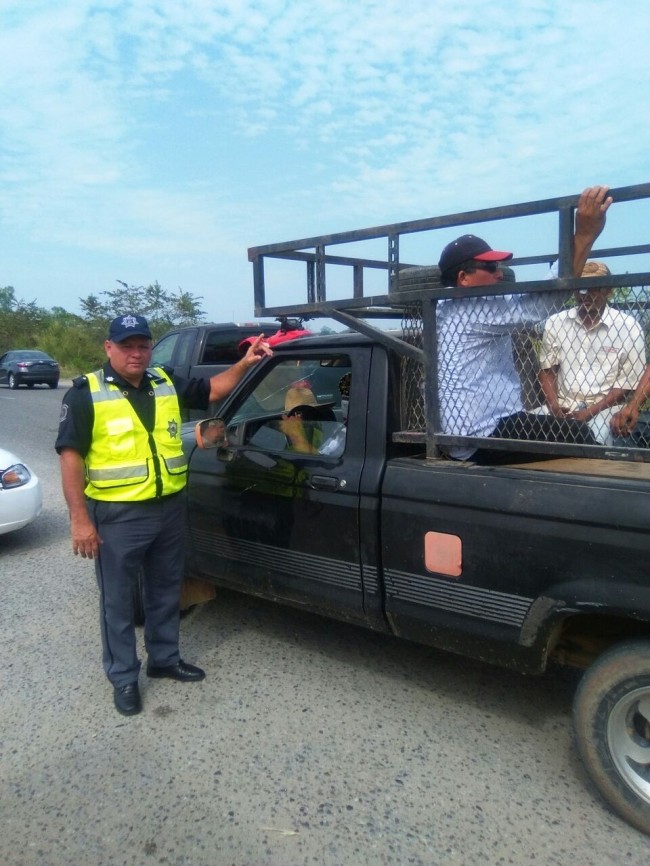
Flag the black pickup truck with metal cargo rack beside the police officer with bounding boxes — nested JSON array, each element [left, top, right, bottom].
[[180, 185, 650, 833]]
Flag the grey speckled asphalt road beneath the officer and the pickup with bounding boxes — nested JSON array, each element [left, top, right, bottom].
[[0, 388, 650, 866]]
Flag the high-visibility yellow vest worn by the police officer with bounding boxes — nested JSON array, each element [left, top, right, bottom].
[[85, 367, 187, 502]]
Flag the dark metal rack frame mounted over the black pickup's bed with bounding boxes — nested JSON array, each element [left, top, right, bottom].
[[248, 183, 650, 460]]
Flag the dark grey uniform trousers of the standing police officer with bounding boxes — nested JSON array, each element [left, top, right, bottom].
[[88, 493, 185, 686]]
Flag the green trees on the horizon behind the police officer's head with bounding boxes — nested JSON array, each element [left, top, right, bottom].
[[0, 280, 205, 375]]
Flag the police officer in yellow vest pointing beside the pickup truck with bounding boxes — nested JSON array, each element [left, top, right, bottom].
[[55, 313, 271, 716]]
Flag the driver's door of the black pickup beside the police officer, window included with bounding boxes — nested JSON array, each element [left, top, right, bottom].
[[188, 347, 370, 620]]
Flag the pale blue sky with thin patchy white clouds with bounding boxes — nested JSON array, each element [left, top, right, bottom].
[[0, 0, 650, 321]]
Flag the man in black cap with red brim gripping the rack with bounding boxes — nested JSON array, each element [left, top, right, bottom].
[[436, 186, 612, 462]]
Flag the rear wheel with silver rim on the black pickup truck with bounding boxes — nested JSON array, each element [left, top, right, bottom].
[[573, 640, 650, 834]]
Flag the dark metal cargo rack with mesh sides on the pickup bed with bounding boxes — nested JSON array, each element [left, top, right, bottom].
[[248, 183, 650, 461]]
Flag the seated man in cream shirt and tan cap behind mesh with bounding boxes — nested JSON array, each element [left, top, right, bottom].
[[539, 262, 646, 445]]
